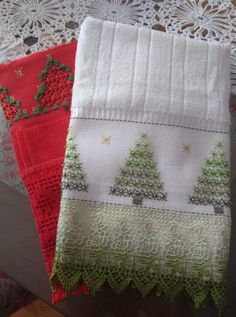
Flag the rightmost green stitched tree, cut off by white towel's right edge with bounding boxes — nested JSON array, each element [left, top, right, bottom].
[[189, 142, 230, 214]]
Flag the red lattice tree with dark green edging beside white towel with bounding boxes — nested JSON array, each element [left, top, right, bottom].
[[33, 56, 74, 115]]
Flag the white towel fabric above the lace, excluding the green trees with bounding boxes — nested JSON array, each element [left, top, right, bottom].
[[66, 18, 230, 214]]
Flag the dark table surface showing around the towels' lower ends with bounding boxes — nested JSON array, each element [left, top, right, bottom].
[[0, 180, 236, 317]]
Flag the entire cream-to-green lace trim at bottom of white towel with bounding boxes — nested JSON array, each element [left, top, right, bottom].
[[51, 199, 230, 312]]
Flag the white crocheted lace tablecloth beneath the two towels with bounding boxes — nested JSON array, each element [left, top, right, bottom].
[[0, 0, 236, 186]]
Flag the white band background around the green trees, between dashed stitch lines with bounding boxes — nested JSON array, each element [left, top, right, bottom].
[[67, 119, 229, 214]]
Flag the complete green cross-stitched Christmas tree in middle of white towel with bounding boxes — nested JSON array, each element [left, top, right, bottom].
[[110, 133, 167, 205]]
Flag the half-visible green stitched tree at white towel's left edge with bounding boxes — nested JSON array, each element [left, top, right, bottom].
[[62, 131, 88, 192]]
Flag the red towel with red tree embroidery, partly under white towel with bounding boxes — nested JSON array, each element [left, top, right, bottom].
[[0, 42, 88, 303]]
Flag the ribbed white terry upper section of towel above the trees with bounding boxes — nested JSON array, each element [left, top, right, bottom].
[[72, 18, 230, 132]]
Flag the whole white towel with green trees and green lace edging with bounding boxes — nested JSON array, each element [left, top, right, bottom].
[[53, 18, 230, 310]]
